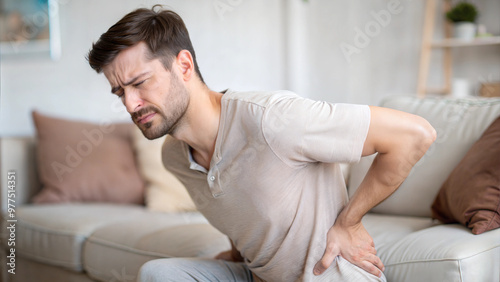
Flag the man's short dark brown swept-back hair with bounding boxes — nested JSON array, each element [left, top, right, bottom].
[[87, 5, 203, 82]]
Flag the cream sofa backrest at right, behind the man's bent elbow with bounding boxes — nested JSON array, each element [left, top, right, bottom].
[[349, 96, 500, 217]]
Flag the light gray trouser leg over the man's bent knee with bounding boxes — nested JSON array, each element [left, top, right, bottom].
[[137, 258, 254, 282]]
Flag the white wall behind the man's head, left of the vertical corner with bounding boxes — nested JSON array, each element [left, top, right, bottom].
[[0, 0, 285, 136]]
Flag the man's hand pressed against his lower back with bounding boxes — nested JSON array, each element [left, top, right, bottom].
[[313, 221, 384, 277]]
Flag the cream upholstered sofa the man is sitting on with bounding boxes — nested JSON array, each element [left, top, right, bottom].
[[0, 96, 500, 282]]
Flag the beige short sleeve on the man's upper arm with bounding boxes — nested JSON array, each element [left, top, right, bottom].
[[262, 96, 370, 165]]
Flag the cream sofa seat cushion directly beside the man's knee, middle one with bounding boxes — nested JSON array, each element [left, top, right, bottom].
[[84, 212, 231, 281]]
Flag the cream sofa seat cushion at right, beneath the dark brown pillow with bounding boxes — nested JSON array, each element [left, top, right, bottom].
[[363, 214, 500, 282]]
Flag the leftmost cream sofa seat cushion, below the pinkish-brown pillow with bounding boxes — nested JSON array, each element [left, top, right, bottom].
[[10, 204, 145, 271]]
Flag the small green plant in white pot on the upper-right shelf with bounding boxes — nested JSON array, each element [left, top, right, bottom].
[[446, 2, 478, 40]]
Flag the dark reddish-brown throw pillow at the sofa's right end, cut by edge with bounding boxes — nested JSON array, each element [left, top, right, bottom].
[[432, 114, 500, 234]]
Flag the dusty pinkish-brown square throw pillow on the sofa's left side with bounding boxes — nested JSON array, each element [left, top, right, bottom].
[[33, 112, 144, 204]]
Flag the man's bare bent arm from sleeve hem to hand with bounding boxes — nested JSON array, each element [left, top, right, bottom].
[[314, 107, 436, 276]]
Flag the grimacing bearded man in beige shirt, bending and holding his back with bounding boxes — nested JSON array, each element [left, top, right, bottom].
[[88, 4, 436, 281]]
